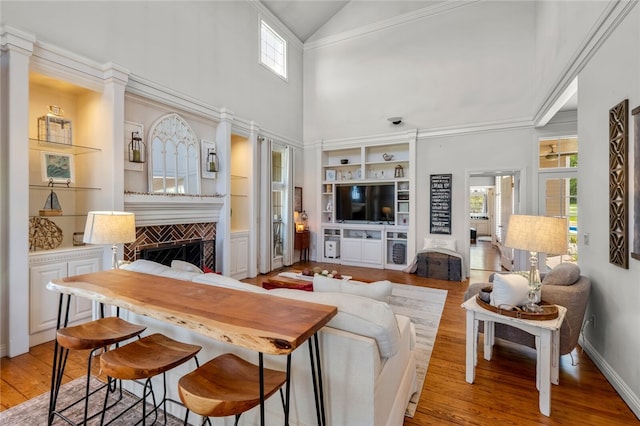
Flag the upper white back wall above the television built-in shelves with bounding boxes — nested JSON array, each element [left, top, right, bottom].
[[304, 2, 535, 143]]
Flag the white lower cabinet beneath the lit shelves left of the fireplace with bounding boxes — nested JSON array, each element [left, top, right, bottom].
[[29, 247, 104, 347]]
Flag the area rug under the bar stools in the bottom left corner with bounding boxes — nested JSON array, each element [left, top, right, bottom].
[[0, 377, 184, 426]]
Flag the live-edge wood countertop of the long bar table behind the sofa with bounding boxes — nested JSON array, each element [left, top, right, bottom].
[[47, 270, 337, 354]]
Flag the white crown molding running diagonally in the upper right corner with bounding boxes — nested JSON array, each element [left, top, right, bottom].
[[533, 0, 638, 127]]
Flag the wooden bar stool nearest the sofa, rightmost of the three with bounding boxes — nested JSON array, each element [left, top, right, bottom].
[[178, 353, 291, 425]]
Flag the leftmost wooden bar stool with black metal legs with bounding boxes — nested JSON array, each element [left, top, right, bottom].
[[48, 317, 146, 424]]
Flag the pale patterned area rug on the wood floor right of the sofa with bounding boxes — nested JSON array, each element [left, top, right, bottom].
[[390, 284, 447, 417]]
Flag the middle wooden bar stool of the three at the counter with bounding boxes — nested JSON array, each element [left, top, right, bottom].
[[100, 333, 202, 425]]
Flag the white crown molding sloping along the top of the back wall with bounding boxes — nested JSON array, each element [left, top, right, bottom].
[[304, 0, 482, 51]]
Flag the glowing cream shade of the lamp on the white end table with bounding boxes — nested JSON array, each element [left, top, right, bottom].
[[504, 214, 567, 254]]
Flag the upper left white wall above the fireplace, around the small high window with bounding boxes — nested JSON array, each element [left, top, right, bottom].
[[0, 1, 302, 140]]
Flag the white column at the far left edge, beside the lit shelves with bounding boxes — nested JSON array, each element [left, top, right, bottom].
[[0, 28, 35, 357]]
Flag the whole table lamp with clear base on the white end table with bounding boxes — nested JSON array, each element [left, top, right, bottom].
[[504, 215, 567, 312]]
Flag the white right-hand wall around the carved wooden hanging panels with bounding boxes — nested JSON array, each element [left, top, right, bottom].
[[578, 3, 640, 417]]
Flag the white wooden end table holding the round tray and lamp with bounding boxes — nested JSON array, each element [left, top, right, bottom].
[[462, 296, 567, 416]]
